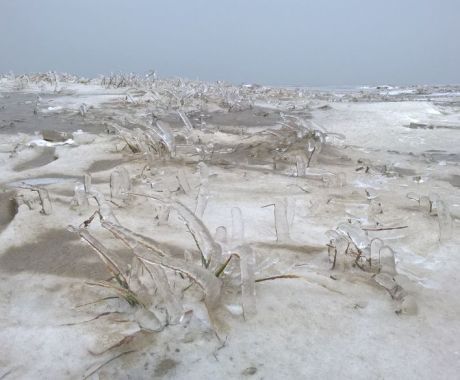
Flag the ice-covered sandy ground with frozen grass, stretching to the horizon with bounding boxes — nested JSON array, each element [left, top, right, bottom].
[[0, 74, 460, 379]]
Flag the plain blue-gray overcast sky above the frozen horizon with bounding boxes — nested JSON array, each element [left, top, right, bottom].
[[0, 0, 460, 86]]
